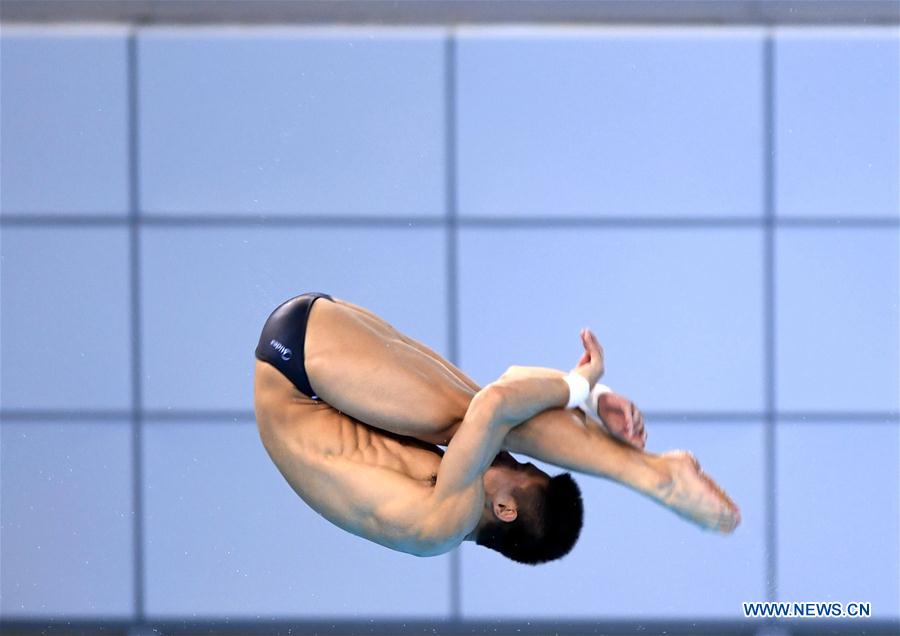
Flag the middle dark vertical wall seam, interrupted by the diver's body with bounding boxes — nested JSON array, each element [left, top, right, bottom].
[[444, 30, 462, 621]]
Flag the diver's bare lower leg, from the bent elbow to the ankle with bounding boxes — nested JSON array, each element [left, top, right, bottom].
[[503, 409, 665, 495]]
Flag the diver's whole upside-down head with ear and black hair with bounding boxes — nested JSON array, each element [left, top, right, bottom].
[[474, 453, 584, 565]]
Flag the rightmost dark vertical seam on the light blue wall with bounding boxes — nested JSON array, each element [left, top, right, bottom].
[[763, 29, 778, 601]]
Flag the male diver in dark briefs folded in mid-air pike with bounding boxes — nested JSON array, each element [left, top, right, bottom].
[[254, 294, 740, 564]]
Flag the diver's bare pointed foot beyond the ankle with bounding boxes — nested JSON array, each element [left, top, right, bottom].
[[659, 451, 741, 534]]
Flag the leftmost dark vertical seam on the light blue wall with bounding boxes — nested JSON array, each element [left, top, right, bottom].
[[127, 28, 144, 623]]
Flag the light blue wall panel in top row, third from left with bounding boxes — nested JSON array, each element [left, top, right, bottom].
[[457, 28, 763, 217]]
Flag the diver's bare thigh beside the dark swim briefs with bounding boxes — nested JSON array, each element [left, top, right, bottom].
[[304, 300, 474, 442]]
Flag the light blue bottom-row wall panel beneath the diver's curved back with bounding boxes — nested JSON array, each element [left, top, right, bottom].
[[144, 422, 450, 620]]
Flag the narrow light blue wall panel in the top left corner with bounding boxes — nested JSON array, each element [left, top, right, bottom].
[[0, 25, 128, 215]]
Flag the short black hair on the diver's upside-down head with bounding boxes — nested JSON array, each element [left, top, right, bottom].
[[476, 473, 584, 565]]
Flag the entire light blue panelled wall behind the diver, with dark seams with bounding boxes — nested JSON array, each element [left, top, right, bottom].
[[0, 23, 900, 619]]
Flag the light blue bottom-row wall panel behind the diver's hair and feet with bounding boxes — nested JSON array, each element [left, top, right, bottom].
[[462, 423, 765, 620]]
